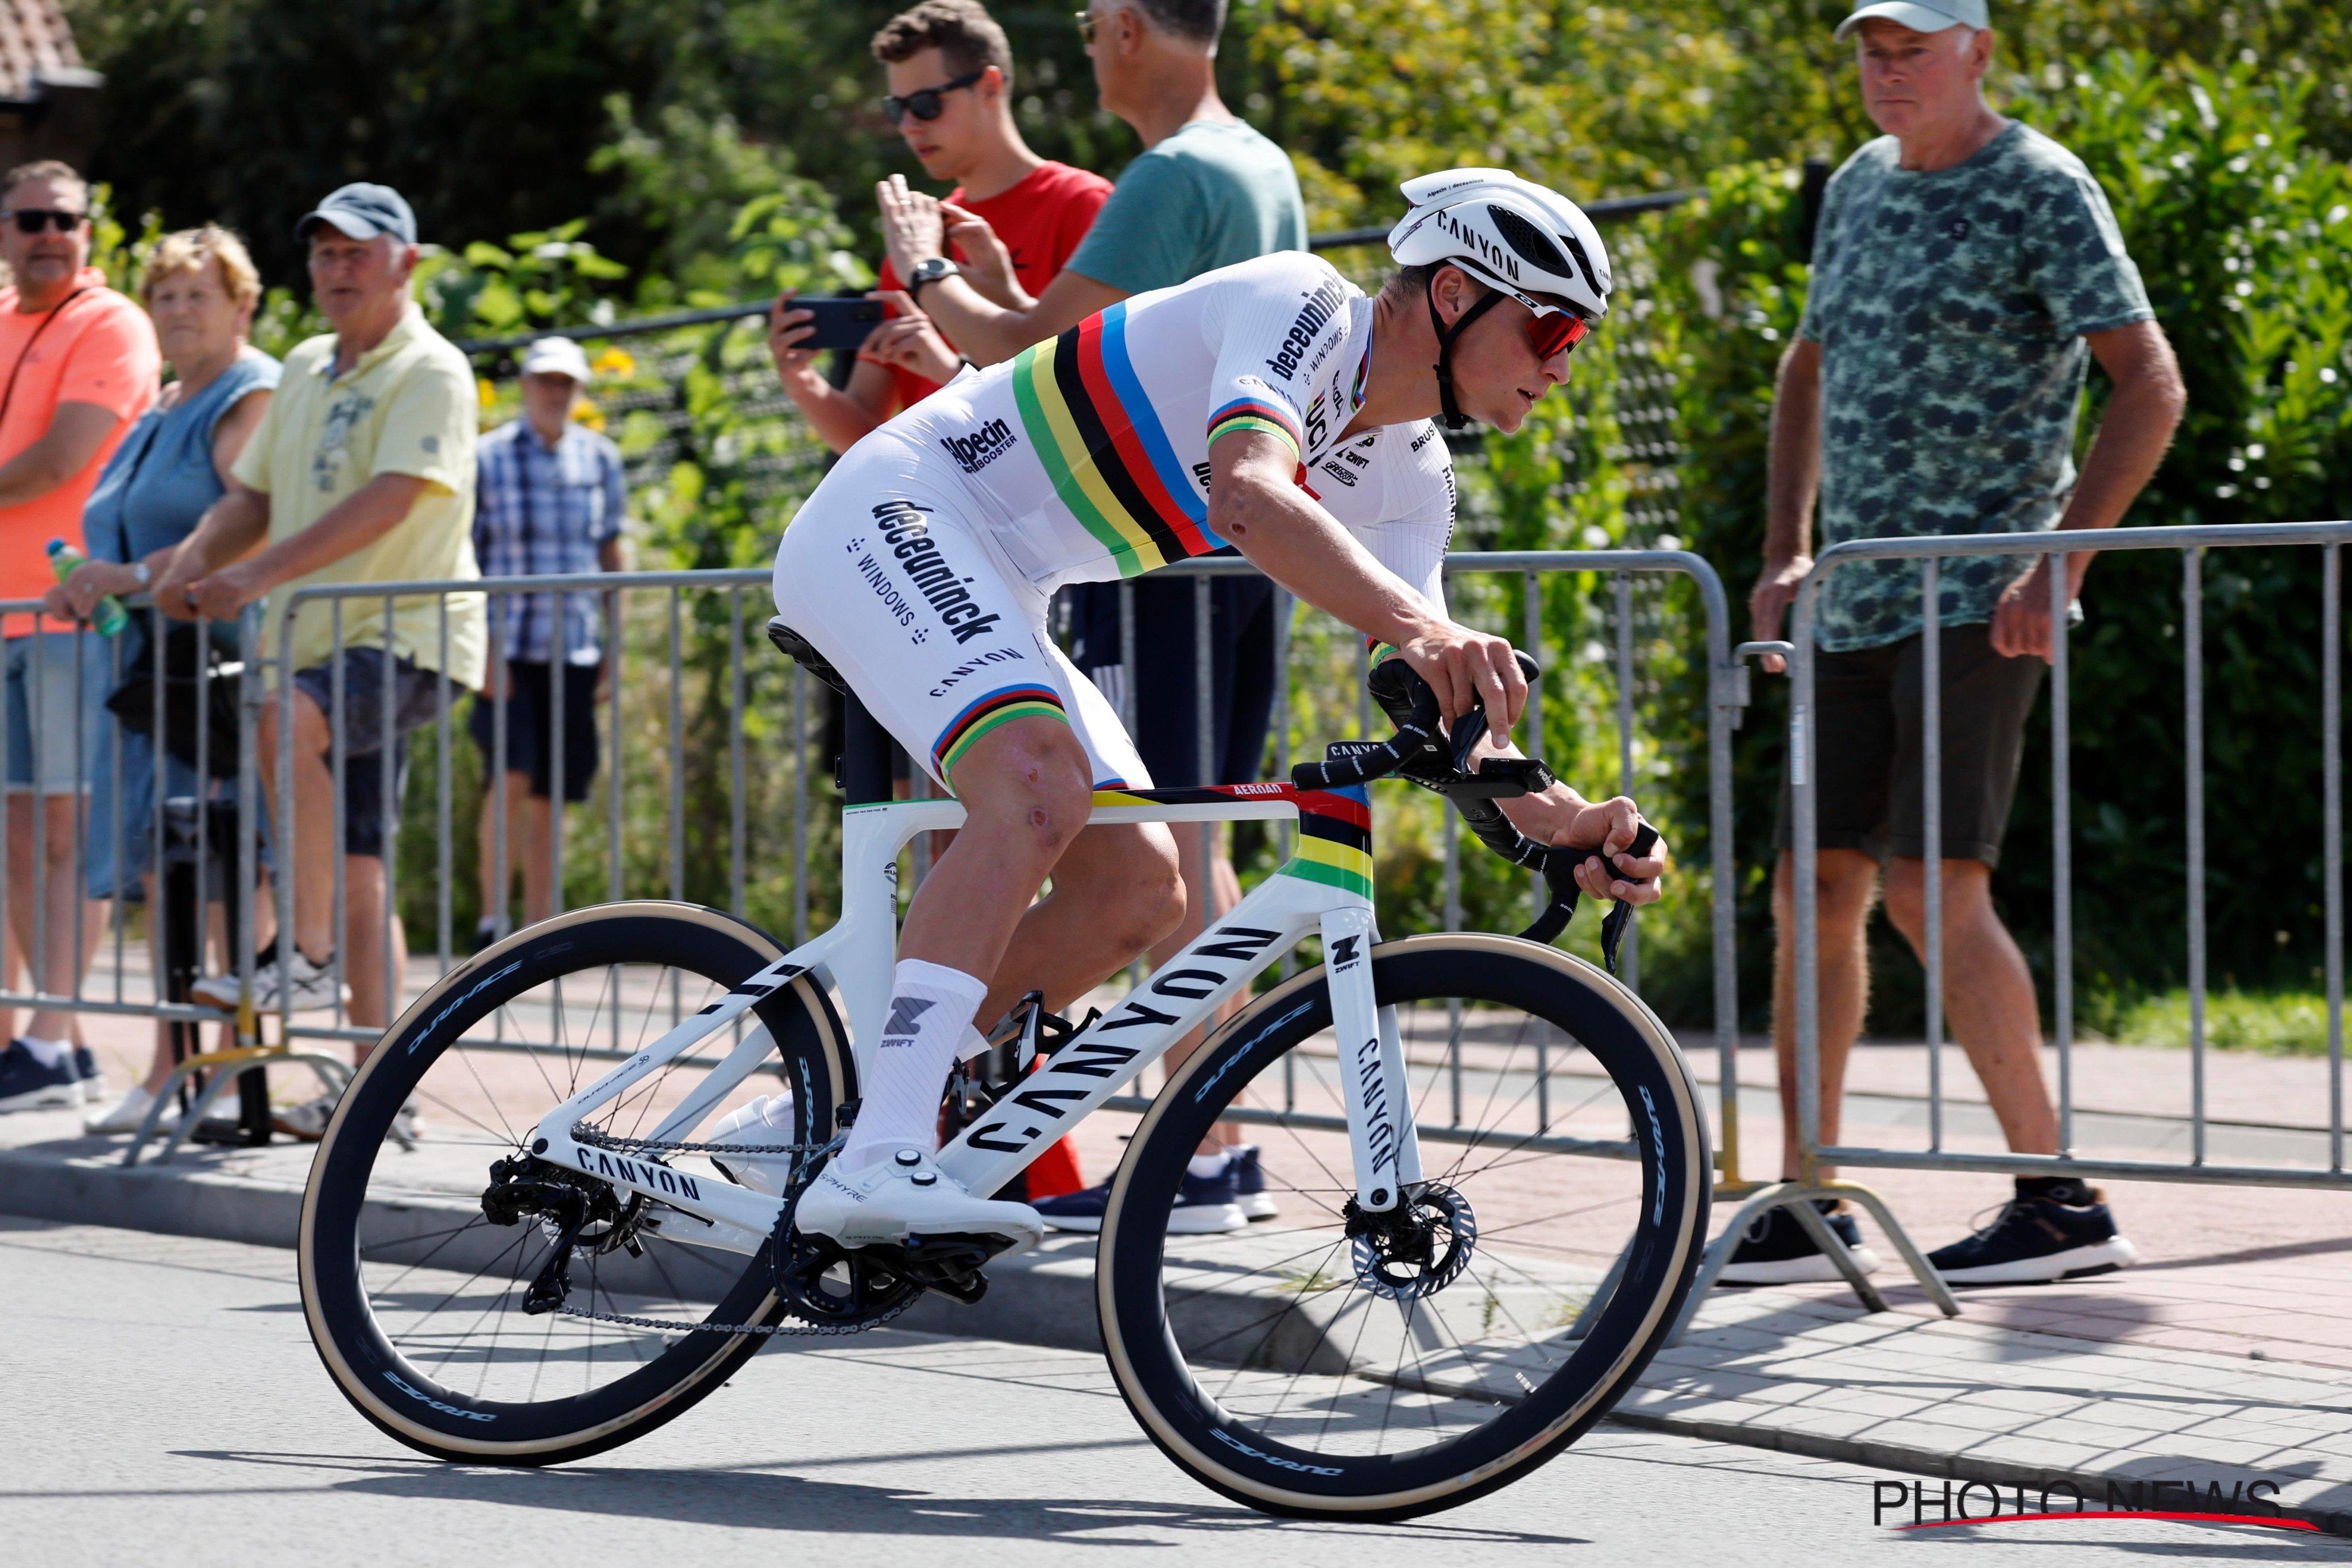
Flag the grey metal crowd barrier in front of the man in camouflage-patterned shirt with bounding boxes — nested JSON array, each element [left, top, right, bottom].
[[1691, 522, 2352, 1312]]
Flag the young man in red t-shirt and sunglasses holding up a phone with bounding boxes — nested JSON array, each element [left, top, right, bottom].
[[767, 0, 1110, 451]]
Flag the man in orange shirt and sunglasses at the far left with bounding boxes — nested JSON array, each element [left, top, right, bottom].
[[0, 160, 163, 1112]]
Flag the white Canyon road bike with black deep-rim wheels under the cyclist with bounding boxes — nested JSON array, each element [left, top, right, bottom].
[[301, 628, 1710, 1519]]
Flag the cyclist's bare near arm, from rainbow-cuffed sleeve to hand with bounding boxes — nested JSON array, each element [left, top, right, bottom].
[[1209, 430, 1526, 745]]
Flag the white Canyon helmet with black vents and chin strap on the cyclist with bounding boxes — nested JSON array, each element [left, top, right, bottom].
[[1388, 169, 1611, 430]]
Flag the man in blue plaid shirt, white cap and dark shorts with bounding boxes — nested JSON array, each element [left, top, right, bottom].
[[473, 339, 628, 950]]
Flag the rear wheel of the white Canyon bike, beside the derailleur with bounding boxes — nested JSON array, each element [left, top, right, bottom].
[[301, 903, 849, 1465]]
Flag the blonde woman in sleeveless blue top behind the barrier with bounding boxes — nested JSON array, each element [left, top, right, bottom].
[[49, 226, 277, 1133]]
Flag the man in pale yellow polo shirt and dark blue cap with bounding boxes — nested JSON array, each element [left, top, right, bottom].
[[155, 183, 487, 1138]]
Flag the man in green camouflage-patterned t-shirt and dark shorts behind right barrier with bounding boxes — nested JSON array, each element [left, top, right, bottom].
[[1724, 0, 2185, 1284]]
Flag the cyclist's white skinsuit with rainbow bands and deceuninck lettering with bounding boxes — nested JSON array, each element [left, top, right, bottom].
[[776, 251, 1453, 788]]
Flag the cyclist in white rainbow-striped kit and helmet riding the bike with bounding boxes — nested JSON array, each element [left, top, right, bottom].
[[776, 169, 1665, 1246]]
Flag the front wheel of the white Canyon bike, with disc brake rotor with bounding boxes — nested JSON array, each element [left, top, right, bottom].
[[1096, 936, 1710, 1519]]
